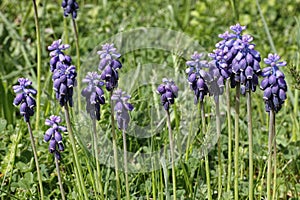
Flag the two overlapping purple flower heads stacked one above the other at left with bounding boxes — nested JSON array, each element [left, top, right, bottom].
[[48, 39, 77, 107]]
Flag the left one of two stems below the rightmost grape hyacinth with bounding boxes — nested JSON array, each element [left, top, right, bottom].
[[267, 110, 275, 200]]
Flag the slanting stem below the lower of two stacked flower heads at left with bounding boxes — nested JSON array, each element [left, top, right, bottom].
[[64, 104, 88, 199]]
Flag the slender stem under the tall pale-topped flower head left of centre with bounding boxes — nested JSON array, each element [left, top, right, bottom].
[[110, 91, 121, 200]]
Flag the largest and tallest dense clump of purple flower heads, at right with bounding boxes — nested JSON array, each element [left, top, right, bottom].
[[210, 24, 261, 94]]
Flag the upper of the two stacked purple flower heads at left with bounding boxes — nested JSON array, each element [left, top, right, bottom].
[[48, 39, 72, 72]]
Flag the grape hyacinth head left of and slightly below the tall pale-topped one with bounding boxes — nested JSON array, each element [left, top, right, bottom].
[[81, 72, 105, 121]]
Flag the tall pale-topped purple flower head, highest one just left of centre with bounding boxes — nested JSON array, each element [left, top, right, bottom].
[[97, 43, 122, 91]]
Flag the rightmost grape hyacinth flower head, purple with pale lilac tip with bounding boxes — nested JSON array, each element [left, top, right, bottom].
[[260, 54, 287, 112]]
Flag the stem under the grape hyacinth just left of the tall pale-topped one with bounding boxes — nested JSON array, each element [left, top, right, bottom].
[[92, 119, 104, 199]]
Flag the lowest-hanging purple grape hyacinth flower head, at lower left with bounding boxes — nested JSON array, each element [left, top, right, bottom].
[[44, 115, 67, 160]]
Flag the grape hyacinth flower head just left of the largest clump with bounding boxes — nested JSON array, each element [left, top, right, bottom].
[[186, 52, 209, 104]]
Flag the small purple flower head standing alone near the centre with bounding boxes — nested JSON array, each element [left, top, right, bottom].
[[157, 78, 178, 111]]
